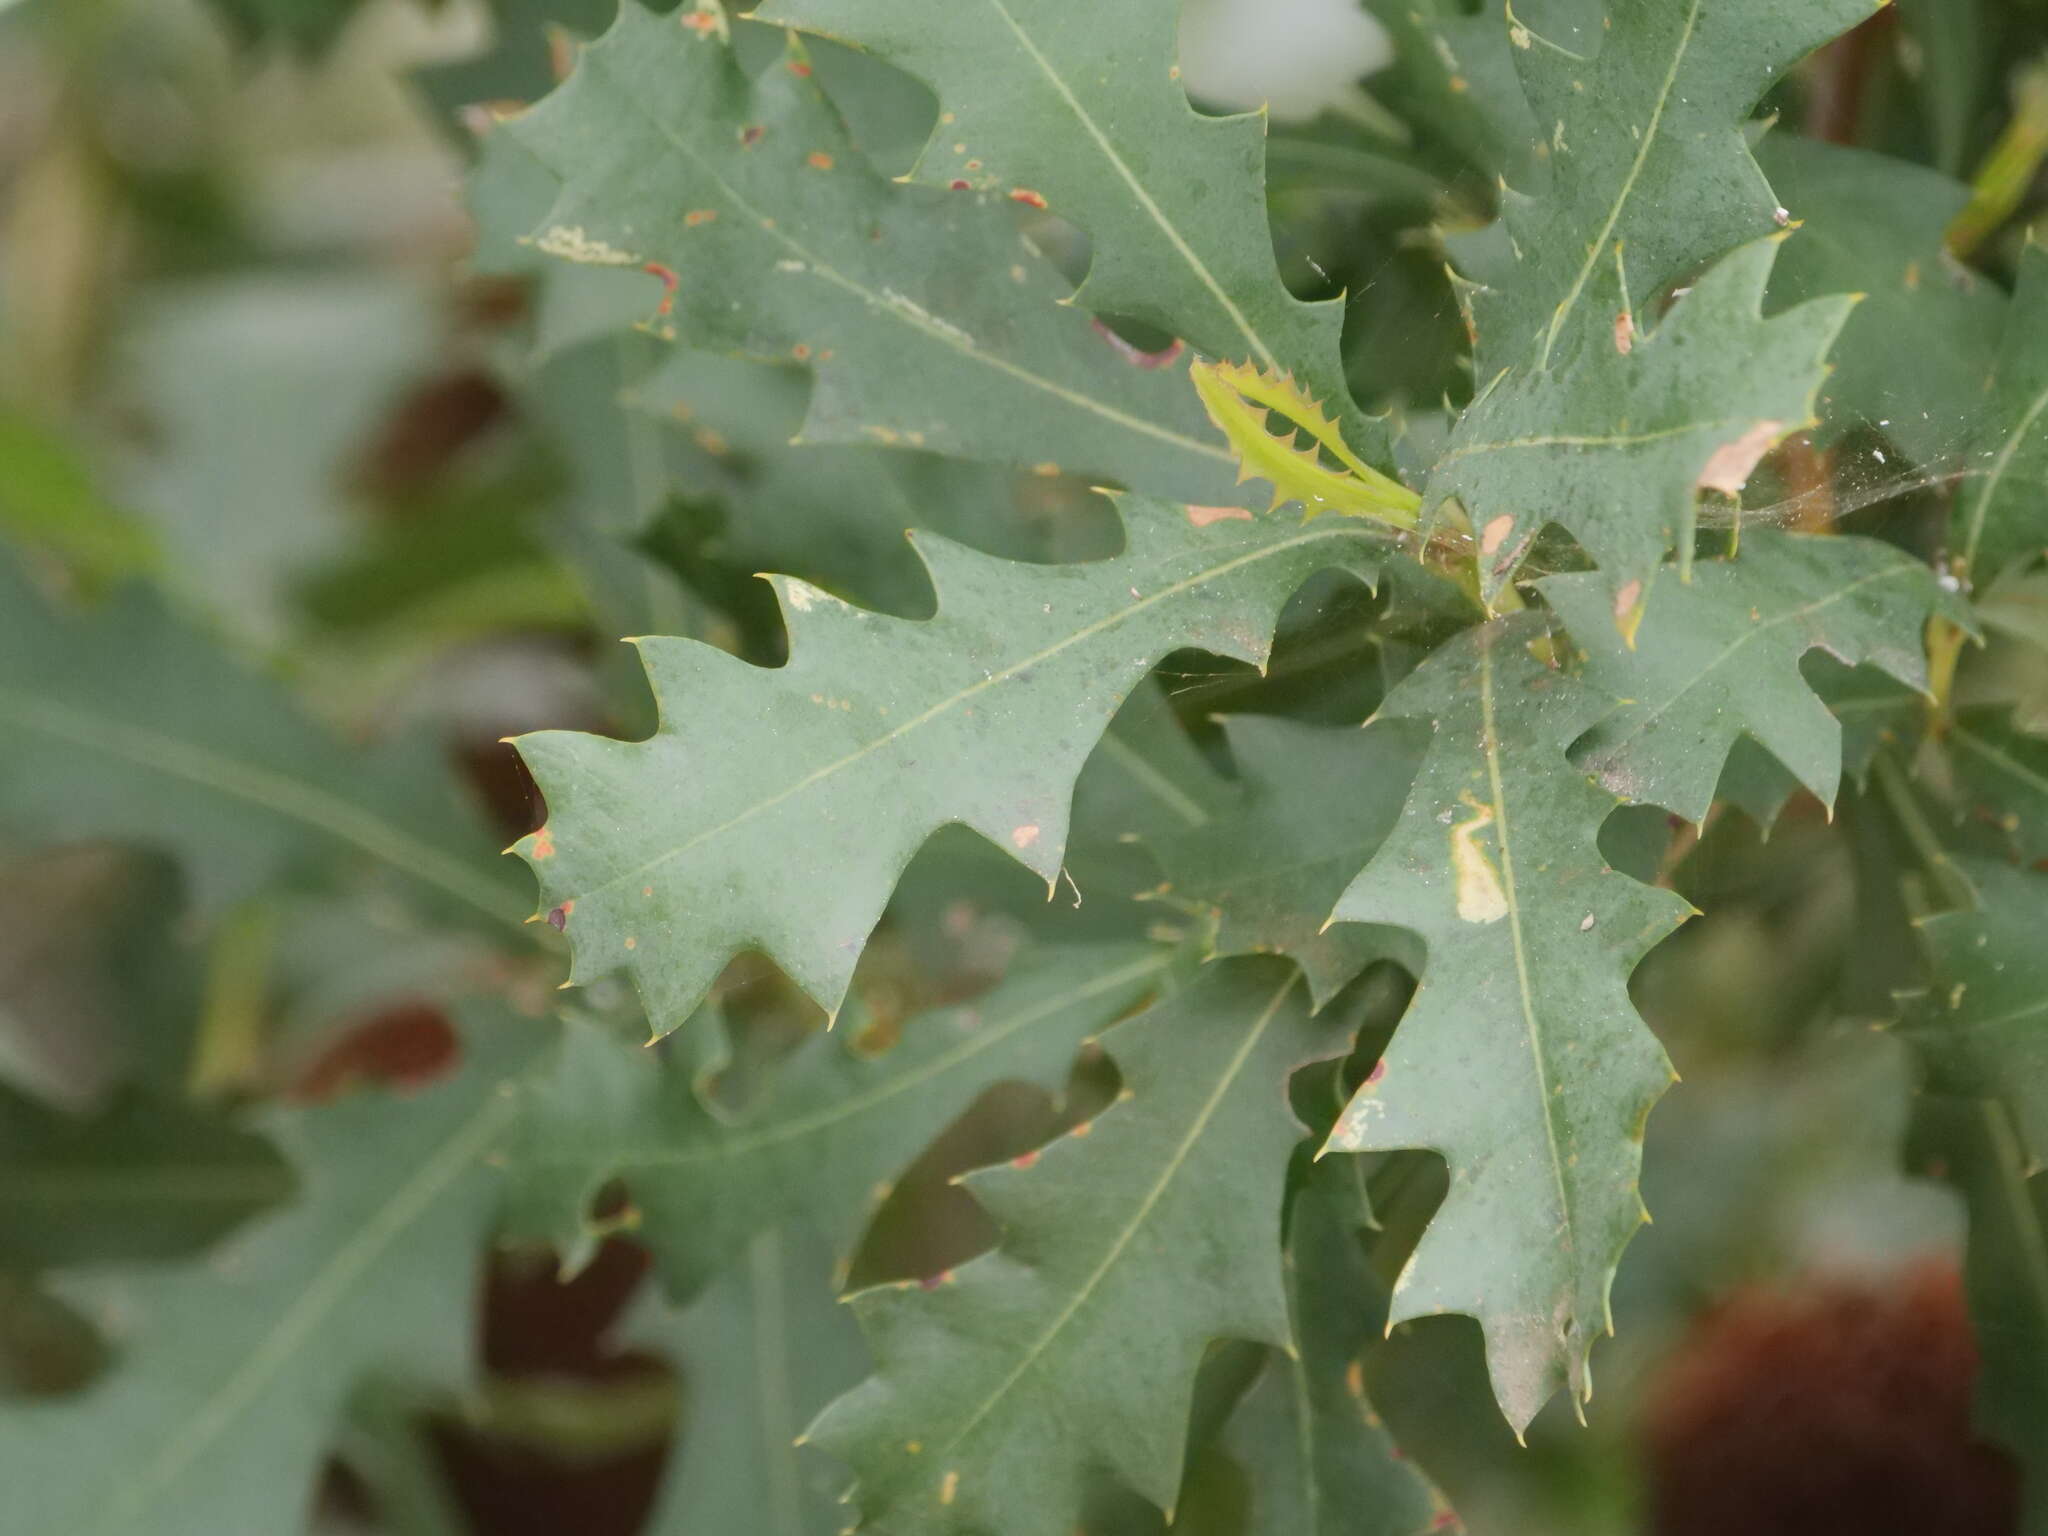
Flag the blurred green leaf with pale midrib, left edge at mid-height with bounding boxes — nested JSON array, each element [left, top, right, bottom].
[[0, 555, 536, 926]]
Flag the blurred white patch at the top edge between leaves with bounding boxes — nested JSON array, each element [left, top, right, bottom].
[[1180, 0, 1393, 123]]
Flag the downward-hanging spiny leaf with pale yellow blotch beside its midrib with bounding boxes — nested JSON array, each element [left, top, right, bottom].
[[1327, 616, 1686, 1432]]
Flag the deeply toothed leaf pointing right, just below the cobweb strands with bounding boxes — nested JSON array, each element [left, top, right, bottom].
[[1540, 528, 1960, 823]]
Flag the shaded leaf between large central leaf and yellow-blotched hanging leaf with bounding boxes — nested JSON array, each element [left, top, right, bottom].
[[1157, 715, 1425, 1008]]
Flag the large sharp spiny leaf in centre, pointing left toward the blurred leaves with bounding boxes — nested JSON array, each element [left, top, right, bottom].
[[516, 498, 1374, 1032]]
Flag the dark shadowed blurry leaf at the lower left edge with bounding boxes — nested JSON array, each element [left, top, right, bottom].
[[0, 1087, 293, 1270]]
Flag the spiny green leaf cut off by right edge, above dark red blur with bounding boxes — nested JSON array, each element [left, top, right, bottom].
[[1901, 860, 2048, 1167]]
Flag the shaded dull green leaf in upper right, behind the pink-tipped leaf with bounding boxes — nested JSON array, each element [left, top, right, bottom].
[[1757, 133, 2005, 471]]
